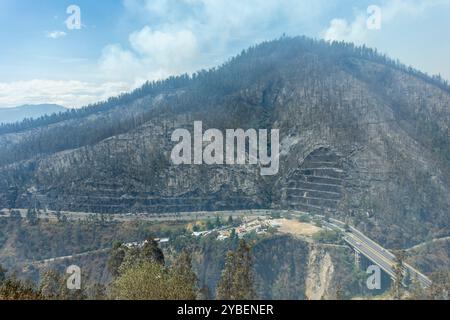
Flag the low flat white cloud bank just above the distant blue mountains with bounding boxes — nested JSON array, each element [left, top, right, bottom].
[[0, 79, 131, 108]]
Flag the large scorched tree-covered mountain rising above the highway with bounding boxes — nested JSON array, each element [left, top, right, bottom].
[[0, 37, 450, 248]]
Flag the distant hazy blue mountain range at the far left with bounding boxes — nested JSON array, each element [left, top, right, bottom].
[[0, 104, 67, 123]]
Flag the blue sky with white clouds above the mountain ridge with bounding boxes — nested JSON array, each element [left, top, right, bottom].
[[0, 0, 450, 108]]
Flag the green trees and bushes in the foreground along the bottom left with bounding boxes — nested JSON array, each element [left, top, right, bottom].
[[0, 238, 257, 300]]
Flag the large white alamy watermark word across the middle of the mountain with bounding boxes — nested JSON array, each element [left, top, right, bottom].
[[170, 121, 280, 176]]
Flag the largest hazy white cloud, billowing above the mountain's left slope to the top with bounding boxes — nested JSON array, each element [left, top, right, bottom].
[[99, 0, 329, 84]]
